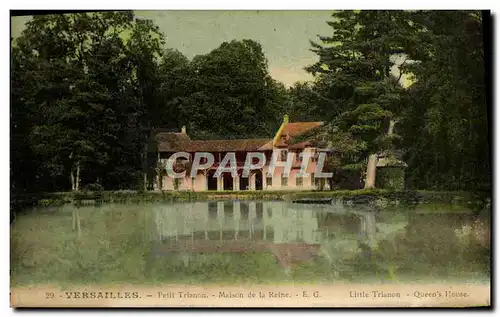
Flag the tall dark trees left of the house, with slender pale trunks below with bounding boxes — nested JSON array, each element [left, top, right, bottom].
[[12, 12, 166, 190]]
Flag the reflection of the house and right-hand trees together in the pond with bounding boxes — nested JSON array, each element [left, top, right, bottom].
[[153, 201, 490, 273]]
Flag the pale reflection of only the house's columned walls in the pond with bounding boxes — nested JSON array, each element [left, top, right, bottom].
[[154, 201, 321, 244]]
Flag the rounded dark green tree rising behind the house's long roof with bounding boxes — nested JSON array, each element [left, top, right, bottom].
[[181, 40, 287, 138]]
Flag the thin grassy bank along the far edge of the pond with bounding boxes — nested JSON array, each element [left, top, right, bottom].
[[12, 189, 484, 207]]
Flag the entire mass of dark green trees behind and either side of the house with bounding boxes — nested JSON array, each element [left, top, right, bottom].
[[11, 11, 491, 195]]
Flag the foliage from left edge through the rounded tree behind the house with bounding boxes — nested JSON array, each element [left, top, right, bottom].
[[11, 12, 287, 194]]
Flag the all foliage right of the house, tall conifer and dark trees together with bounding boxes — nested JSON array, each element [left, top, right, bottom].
[[290, 11, 491, 191]]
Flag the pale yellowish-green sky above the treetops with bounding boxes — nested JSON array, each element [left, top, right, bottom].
[[11, 11, 331, 86]]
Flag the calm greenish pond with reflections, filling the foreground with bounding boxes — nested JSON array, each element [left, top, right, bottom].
[[11, 201, 491, 285]]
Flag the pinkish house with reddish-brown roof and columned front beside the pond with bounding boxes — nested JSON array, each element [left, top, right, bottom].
[[150, 116, 323, 191]]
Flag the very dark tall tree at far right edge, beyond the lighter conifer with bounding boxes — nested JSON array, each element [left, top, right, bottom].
[[399, 11, 491, 191]]
